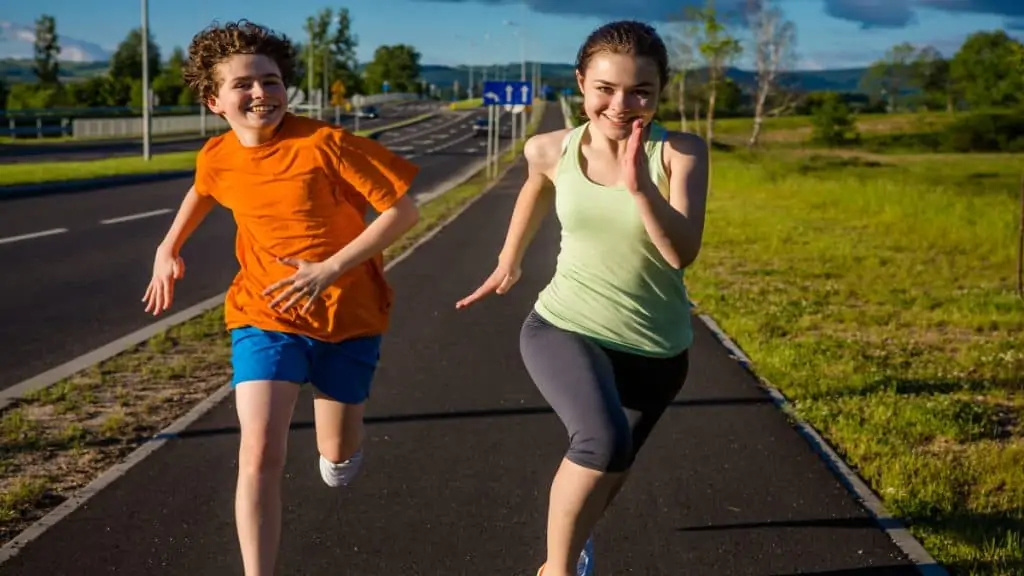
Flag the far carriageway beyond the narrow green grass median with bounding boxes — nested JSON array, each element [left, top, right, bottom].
[[0, 101, 439, 164]]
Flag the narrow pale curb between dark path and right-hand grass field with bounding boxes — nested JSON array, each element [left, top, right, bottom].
[[690, 300, 949, 576]]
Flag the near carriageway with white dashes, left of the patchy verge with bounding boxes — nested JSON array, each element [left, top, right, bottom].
[[0, 103, 516, 389]]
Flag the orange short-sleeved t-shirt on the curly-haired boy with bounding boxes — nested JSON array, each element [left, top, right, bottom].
[[196, 114, 419, 342]]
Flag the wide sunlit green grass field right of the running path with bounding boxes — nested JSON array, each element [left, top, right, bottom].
[[688, 145, 1024, 576]]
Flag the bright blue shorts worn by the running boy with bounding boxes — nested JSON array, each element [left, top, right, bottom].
[[231, 326, 381, 404]]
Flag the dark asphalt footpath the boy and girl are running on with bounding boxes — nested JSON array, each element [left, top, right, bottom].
[[0, 107, 914, 576]]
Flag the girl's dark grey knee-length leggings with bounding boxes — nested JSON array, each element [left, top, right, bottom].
[[519, 312, 689, 472]]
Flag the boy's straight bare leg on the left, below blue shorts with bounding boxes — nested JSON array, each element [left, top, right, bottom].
[[234, 380, 299, 576]]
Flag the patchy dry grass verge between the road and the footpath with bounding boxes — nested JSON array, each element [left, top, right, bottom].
[[0, 105, 544, 545]]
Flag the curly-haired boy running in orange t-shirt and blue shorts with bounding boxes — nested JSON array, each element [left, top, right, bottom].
[[143, 20, 418, 576]]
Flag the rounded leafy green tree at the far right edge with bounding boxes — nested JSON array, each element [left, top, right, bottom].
[[949, 30, 1024, 108]]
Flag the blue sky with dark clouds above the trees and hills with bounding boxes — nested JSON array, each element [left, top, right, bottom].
[[0, 0, 1024, 70]]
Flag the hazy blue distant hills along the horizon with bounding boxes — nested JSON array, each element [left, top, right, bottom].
[[0, 58, 865, 92]]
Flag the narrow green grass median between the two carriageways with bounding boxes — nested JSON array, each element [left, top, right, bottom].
[[0, 114, 433, 187]]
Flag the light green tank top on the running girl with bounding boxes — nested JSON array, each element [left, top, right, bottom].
[[535, 123, 693, 358]]
